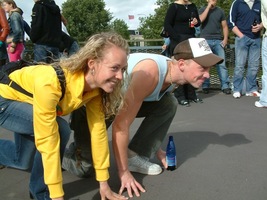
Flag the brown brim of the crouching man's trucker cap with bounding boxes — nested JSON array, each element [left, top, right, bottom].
[[192, 53, 223, 67]]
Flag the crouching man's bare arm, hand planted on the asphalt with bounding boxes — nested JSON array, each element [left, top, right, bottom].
[[112, 60, 158, 197]]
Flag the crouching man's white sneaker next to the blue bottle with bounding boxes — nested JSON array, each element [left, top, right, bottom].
[[128, 155, 162, 175]]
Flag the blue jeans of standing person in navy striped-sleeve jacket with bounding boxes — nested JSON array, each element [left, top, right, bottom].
[[233, 35, 261, 92]]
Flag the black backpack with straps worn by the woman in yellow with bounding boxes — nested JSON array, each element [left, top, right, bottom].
[[0, 59, 66, 101]]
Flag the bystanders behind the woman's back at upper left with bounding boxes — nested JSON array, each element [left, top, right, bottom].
[[0, 0, 79, 65]]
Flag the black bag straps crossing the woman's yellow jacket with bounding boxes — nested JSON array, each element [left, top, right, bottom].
[[0, 65, 66, 101]]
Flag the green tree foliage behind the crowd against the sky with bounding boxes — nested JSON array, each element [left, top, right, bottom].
[[62, 0, 236, 42]]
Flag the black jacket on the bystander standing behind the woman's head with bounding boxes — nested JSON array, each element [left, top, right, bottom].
[[30, 0, 61, 47]]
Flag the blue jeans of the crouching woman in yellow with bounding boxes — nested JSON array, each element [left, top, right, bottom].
[[0, 96, 71, 200]]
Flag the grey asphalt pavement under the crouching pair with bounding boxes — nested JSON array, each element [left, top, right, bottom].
[[0, 90, 267, 200]]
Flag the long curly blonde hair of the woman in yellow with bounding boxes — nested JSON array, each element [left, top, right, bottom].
[[59, 32, 129, 117]]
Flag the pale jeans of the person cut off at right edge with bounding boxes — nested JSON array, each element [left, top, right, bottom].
[[260, 37, 267, 106]]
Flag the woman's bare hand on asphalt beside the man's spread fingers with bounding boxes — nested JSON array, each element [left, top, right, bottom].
[[99, 181, 128, 200]]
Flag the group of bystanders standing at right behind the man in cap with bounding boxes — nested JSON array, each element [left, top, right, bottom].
[[163, 0, 264, 107]]
